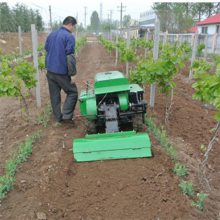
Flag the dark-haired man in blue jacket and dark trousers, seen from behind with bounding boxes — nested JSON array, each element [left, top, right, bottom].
[[45, 16, 78, 122]]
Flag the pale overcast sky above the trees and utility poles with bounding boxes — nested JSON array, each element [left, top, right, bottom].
[[4, 0, 153, 25]]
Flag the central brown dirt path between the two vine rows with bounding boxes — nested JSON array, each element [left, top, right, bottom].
[[0, 40, 197, 220]]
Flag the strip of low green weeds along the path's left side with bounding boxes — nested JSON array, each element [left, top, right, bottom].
[[0, 131, 42, 200]]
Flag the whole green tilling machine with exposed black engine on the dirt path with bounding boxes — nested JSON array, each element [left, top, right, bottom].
[[73, 71, 152, 162]]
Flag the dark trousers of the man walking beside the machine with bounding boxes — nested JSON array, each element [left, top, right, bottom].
[[47, 71, 78, 122]]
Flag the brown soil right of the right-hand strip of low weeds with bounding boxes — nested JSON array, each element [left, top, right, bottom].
[[146, 74, 220, 219]]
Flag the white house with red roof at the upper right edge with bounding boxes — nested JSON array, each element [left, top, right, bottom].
[[196, 13, 220, 34]]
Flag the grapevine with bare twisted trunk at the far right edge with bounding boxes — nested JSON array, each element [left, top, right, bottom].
[[192, 56, 220, 191]]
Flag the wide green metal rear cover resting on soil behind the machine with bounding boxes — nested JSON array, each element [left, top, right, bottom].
[[73, 131, 152, 162]]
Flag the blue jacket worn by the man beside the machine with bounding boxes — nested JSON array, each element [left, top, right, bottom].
[[45, 27, 75, 75]]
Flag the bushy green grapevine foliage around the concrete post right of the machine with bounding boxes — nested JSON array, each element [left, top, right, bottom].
[[129, 44, 190, 94]]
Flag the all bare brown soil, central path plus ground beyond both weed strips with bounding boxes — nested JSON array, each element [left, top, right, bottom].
[[0, 38, 220, 220]]
